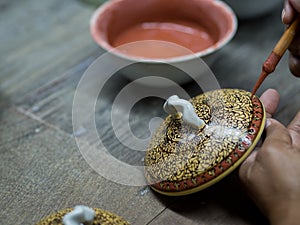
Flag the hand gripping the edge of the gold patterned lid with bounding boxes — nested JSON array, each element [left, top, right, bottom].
[[239, 90, 300, 225]]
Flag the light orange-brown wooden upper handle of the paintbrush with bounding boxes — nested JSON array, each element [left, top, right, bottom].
[[273, 16, 300, 57]]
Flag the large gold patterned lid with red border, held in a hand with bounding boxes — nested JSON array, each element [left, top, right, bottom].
[[144, 89, 265, 196]]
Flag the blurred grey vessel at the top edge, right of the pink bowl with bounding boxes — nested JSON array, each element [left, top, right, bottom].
[[223, 0, 283, 19]]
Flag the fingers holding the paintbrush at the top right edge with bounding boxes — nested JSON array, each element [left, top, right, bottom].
[[282, 0, 300, 77]]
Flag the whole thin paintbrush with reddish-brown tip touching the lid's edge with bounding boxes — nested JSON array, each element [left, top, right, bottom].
[[251, 16, 300, 97]]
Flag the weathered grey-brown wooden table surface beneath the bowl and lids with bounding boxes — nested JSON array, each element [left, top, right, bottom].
[[0, 0, 300, 225]]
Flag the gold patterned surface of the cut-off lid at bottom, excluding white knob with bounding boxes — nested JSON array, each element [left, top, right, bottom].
[[36, 208, 129, 225]]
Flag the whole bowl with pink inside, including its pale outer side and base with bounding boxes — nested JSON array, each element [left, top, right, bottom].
[[90, 0, 237, 85]]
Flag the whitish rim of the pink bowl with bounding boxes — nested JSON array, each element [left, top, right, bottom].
[[89, 0, 238, 63]]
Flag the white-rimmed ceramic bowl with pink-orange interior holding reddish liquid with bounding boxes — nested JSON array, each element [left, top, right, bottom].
[[90, 0, 237, 83]]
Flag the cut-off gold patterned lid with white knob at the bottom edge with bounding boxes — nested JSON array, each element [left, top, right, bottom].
[[36, 206, 129, 225]]
